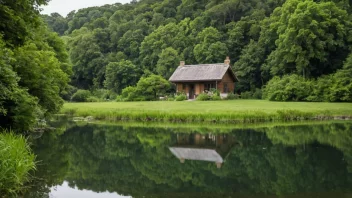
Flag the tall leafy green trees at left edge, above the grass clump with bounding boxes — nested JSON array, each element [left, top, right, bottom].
[[0, 0, 72, 131]]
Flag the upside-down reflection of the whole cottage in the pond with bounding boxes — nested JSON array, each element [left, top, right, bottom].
[[169, 134, 235, 168]]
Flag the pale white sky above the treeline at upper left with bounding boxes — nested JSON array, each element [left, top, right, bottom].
[[41, 0, 131, 17]]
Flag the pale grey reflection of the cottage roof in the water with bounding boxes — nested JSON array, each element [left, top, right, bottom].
[[169, 147, 224, 163]]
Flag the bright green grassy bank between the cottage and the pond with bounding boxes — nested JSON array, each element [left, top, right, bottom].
[[61, 100, 352, 123]]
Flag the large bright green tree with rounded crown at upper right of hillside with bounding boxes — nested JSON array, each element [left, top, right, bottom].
[[268, 0, 352, 77]]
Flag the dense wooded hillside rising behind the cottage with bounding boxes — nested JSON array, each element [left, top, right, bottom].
[[43, 0, 352, 101]]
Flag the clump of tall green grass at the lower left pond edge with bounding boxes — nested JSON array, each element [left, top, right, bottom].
[[0, 131, 35, 197]]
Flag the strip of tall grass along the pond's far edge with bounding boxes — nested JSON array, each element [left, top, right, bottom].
[[63, 109, 340, 123]]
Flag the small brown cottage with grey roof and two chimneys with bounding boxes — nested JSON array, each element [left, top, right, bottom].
[[169, 57, 238, 99]]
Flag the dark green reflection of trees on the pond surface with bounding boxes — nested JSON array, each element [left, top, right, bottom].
[[27, 124, 352, 197]]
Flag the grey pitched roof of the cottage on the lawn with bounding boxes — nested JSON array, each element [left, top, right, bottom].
[[169, 63, 238, 82]]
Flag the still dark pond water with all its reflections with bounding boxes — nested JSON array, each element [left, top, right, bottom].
[[25, 121, 352, 198]]
